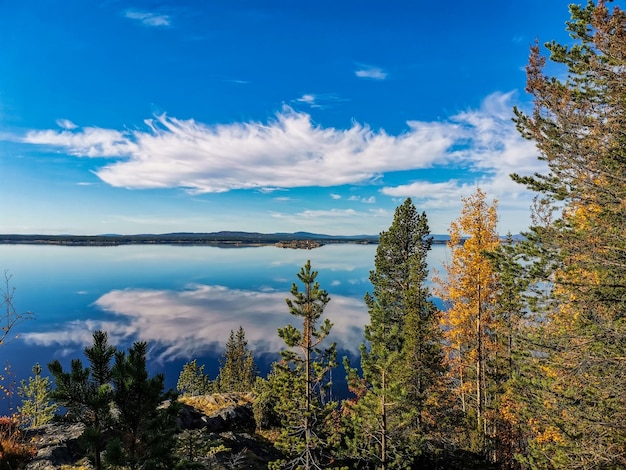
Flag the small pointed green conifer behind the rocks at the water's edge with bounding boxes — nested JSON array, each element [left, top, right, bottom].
[[218, 326, 257, 392]]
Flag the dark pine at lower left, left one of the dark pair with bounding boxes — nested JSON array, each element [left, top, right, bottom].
[[48, 331, 115, 470]]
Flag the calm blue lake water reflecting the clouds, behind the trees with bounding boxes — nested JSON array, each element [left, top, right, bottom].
[[0, 244, 447, 412]]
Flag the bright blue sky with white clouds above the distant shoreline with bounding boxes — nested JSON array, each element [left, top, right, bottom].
[[0, 0, 570, 234]]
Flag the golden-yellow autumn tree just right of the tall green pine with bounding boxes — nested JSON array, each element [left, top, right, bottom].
[[436, 188, 500, 454]]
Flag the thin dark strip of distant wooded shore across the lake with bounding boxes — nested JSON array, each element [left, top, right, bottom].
[[0, 231, 448, 249]]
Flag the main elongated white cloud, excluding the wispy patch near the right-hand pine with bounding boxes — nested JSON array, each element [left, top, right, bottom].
[[23, 108, 462, 193]]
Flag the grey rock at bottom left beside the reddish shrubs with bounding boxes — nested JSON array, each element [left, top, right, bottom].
[[25, 423, 93, 470]]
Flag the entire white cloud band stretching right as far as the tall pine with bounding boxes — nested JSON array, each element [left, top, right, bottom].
[[14, 93, 544, 228]]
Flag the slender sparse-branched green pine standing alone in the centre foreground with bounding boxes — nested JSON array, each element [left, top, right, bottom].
[[272, 261, 336, 470]]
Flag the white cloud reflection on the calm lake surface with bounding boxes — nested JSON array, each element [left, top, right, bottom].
[[23, 285, 369, 359]]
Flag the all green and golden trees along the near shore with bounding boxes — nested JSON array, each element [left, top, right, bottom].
[[0, 0, 626, 470]]
